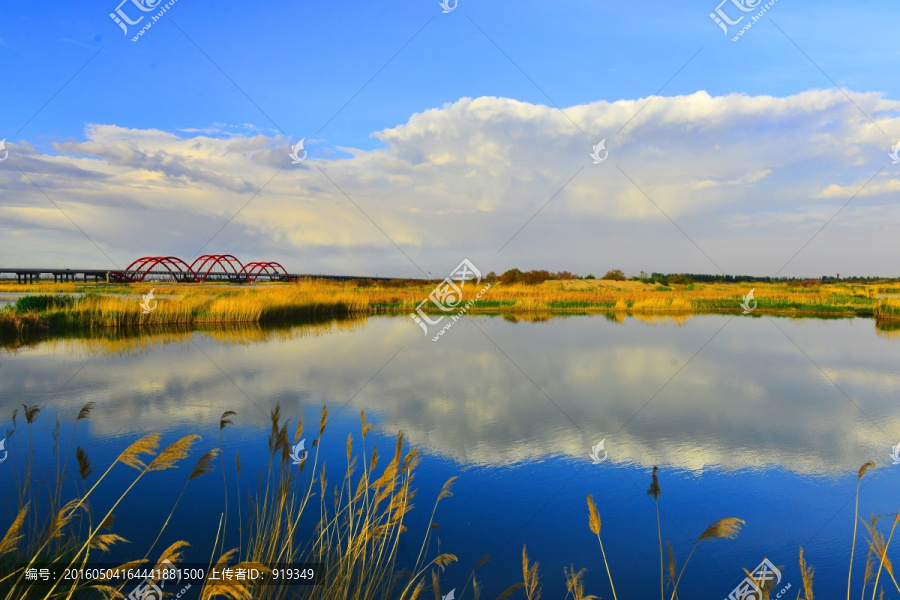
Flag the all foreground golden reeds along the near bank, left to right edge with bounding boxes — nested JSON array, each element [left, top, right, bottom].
[[0, 402, 900, 600]]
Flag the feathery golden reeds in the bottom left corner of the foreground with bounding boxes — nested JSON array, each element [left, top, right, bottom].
[[0, 403, 209, 600]]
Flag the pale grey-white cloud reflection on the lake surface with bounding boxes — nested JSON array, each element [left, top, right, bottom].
[[0, 316, 900, 473]]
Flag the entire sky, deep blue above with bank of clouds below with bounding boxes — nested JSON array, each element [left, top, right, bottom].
[[0, 0, 900, 276]]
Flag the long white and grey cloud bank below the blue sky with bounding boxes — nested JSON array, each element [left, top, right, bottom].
[[0, 90, 900, 275]]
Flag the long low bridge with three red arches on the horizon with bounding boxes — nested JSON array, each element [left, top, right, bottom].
[[0, 254, 400, 283]]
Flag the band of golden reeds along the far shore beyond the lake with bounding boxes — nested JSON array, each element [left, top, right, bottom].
[[0, 274, 900, 337]]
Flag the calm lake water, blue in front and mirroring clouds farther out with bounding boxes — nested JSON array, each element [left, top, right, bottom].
[[0, 316, 900, 598]]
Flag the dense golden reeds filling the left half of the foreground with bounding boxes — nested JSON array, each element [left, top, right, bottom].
[[0, 404, 460, 600]]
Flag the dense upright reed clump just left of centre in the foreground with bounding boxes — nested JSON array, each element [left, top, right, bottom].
[[229, 406, 456, 600]]
